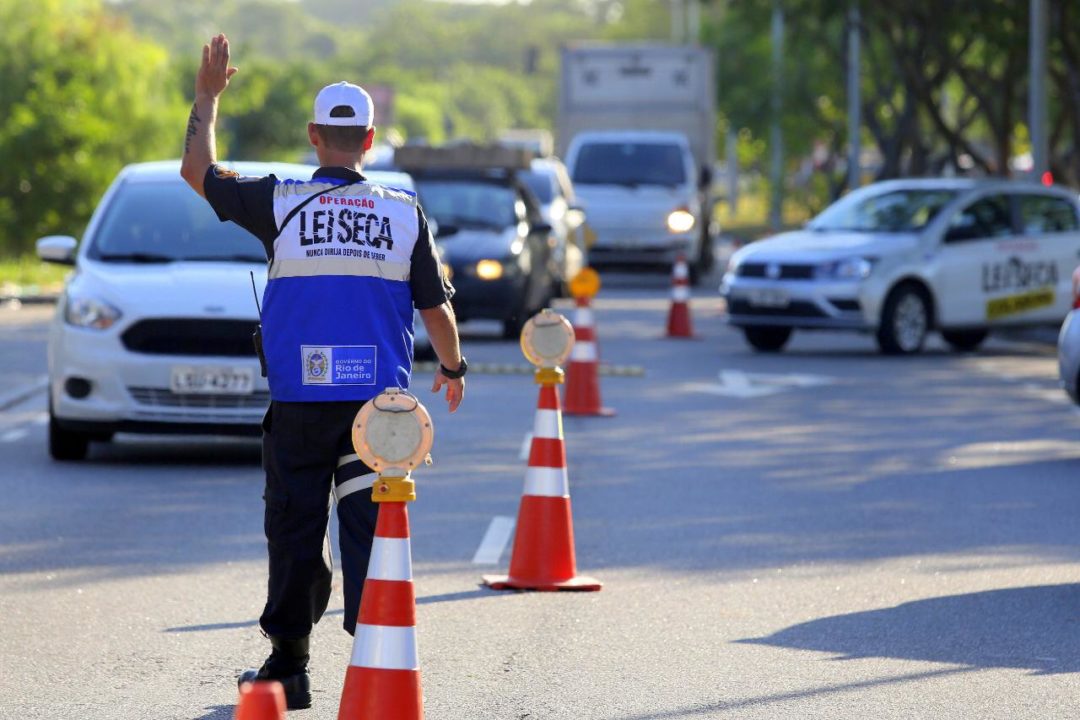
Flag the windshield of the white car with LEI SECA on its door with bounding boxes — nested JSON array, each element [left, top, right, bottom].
[[807, 189, 957, 232]]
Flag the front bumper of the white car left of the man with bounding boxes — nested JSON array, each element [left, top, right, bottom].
[[49, 325, 270, 434]]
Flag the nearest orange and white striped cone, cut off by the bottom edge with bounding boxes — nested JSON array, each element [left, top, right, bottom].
[[338, 498, 423, 720]]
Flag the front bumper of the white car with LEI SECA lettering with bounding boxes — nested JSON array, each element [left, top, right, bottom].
[[720, 275, 876, 330]]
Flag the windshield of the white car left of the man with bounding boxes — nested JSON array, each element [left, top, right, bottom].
[[87, 181, 266, 262]]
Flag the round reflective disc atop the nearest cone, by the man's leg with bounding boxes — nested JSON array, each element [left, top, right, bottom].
[[352, 388, 435, 474]]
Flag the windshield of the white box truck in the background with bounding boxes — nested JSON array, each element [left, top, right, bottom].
[[572, 142, 686, 187]]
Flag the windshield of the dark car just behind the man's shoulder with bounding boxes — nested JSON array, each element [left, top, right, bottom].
[[416, 179, 517, 234]]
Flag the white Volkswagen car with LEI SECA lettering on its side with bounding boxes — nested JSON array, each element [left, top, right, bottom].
[[720, 179, 1080, 354]]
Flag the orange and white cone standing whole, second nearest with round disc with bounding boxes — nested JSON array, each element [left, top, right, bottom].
[[484, 368, 600, 590]]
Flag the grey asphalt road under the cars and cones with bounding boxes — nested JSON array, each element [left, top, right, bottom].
[[0, 276, 1080, 720]]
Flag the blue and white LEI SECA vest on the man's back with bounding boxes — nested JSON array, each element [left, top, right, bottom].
[[262, 178, 419, 403]]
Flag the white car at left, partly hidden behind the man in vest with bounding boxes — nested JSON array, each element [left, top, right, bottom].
[[38, 162, 423, 460]]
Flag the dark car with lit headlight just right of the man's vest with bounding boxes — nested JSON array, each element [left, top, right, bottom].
[[410, 169, 559, 338]]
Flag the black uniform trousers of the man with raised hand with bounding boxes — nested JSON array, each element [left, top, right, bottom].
[[259, 402, 379, 639]]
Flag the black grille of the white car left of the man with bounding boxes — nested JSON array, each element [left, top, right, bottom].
[[121, 317, 258, 357]]
